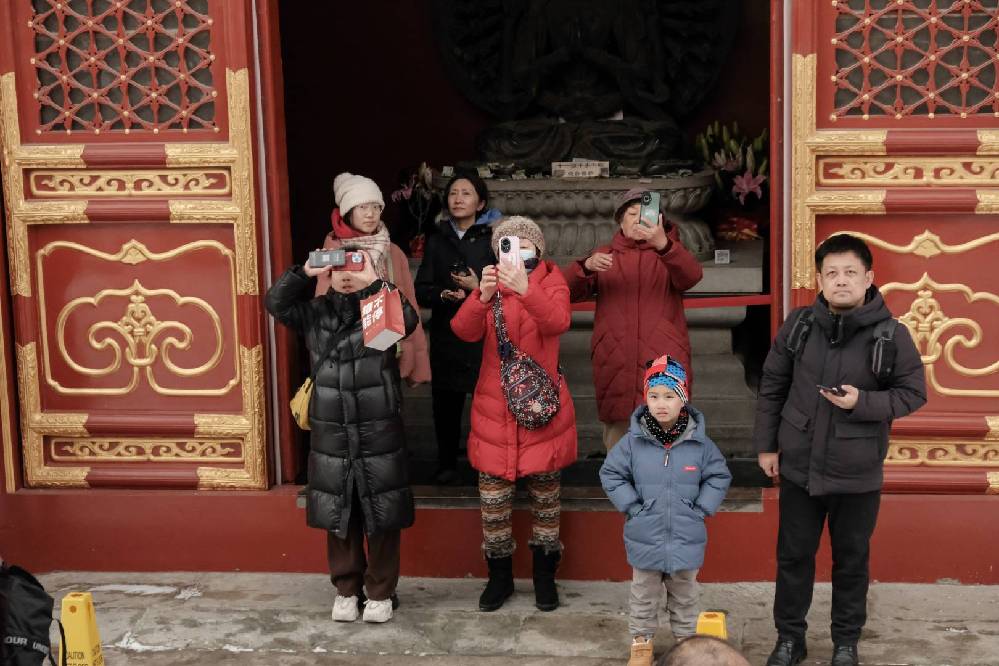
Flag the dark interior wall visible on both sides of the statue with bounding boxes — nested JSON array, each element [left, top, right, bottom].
[[279, 0, 770, 260]]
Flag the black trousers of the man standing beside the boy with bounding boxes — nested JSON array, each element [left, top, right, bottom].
[[774, 477, 881, 644]]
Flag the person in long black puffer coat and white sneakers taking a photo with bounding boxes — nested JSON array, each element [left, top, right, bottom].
[[264, 249, 420, 622]]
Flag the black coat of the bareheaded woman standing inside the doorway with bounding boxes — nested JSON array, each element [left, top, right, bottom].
[[415, 220, 496, 393]]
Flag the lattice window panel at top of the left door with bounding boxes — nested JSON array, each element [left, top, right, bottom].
[[30, 0, 219, 134]]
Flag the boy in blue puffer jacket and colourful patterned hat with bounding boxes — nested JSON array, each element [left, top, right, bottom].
[[600, 356, 732, 666]]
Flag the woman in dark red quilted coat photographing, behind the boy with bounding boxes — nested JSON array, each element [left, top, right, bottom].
[[563, 189, 703, 451]]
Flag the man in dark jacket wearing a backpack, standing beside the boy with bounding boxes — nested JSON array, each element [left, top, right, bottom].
[[753, 234, 926, 666]]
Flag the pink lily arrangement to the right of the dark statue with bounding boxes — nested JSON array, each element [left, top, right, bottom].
[[696, 120, 768, 206]]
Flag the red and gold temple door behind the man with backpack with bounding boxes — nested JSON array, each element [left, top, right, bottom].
[[788, 0, 999, 492]]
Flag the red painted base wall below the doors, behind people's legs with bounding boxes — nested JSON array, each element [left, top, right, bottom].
[[0, 486, 999, 585]]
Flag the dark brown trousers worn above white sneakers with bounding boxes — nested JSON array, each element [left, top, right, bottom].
[[326, 495, 402, 601]]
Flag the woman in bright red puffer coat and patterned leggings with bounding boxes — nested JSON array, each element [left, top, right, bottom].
[[451, 217, 576, 611]]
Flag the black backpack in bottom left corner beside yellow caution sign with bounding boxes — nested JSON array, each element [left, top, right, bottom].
[[0, 564, 67, 666]]
